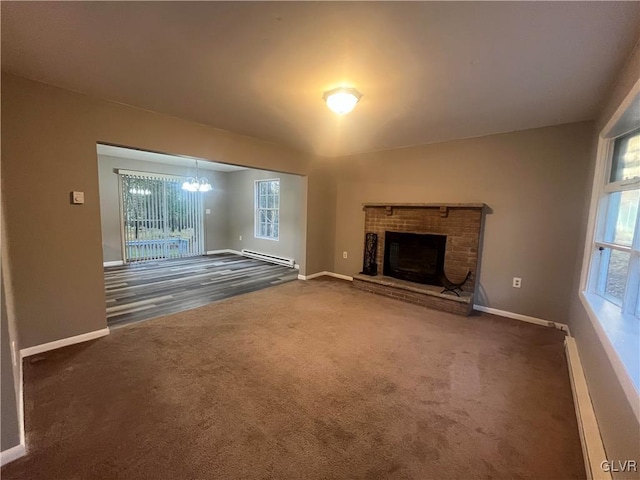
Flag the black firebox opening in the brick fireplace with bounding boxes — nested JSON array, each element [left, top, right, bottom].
[[383, 232, 447, 286]]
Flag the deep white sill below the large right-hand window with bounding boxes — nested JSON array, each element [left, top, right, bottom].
[[580, 292, 640, 421]]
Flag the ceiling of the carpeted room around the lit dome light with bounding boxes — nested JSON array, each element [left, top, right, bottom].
[[1, 2, 640, 156]]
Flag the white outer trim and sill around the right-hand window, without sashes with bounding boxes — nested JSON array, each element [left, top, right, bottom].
[[579, 79, 640, 422]]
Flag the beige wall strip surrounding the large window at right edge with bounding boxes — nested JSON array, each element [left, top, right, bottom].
[[568, 37, 640, 479]]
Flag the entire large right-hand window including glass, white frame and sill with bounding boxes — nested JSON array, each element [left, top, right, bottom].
[[580, 78, 640, 418]]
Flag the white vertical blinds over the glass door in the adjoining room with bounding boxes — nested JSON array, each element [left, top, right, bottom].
[[118, 170, 204, 262]]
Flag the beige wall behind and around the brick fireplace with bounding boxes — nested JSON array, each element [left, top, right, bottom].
[[334, 122, 593, 323]]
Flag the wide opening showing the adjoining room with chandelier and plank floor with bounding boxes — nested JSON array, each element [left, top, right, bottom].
[[97, 144, 307, 328]]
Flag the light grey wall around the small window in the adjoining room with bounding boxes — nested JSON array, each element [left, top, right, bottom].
[[227, 170, 304, 263]]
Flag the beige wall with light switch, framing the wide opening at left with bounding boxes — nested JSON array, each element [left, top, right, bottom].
[[1, 73, 333, 348]]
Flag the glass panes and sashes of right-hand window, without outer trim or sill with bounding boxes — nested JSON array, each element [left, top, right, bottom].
[[588, 129, 640, 319]]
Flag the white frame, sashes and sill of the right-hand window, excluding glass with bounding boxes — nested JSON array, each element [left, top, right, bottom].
[[578, 78, 640, 421]]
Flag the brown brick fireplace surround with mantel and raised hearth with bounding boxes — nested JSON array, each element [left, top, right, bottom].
[[353, 203, 486, 315]]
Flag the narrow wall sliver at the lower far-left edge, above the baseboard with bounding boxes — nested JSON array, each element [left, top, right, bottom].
[[0, 274, 20, 451]]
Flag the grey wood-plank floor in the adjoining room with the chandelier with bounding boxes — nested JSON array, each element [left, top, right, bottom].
[[104, 253, 298, 327]]
